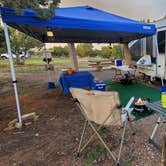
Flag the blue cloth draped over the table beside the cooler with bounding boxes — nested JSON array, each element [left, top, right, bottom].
[[59, 71, 94, 94]]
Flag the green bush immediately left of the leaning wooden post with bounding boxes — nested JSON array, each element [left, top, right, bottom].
[[52, 46, 69, 57]]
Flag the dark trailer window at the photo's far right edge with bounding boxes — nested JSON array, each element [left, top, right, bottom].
[[157, 31, 165, 53]]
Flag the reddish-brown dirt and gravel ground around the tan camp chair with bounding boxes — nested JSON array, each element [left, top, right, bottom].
[[0, 71, 164, 166]]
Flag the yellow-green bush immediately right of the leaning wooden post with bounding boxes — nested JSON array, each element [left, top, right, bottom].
[[76, 44, 93, 57]]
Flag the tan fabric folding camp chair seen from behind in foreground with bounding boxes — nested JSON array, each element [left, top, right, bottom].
[[70, 88, 134, 165]]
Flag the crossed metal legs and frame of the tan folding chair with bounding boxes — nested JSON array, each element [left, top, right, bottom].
[[75, 98, 134, 165]]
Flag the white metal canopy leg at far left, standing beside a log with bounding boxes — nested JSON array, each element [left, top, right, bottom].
[[3, 23, 22, 127]]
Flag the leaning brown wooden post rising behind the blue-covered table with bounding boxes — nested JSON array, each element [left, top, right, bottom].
[[68, 43, 78, 71]]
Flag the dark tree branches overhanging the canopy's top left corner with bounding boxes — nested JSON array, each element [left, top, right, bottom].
[[0, 0, 60, 20]]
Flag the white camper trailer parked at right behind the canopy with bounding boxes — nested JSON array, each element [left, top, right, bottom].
[[129, 19, 166, 81]]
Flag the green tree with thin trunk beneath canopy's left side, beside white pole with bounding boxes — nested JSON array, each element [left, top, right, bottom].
[[9, 28, 43, 64]]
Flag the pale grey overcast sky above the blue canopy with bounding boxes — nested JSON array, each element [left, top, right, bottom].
[[60, 0, 166, 20]]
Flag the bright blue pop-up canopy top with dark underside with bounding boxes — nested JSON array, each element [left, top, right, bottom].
[[0, 6, 156, 43]]
